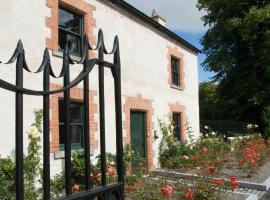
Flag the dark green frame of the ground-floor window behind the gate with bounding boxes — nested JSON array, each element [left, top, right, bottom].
[[58, 99, 84, 151]]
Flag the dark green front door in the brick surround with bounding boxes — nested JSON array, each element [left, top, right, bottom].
[[130, 111, 146, 158]]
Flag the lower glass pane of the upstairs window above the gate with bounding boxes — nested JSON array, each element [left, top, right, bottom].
[[58, 30, 82, 55]]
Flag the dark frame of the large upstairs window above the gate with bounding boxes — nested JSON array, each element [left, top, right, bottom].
[[57, 5, 84, 57]]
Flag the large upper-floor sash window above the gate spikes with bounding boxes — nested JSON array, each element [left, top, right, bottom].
[[58, 7, 83, 56]]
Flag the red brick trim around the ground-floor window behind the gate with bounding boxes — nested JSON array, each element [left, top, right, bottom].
[[50, 83, 98, 153]]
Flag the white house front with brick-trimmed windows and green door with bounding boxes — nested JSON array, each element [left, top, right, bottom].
[[0, 0, 199, 175]]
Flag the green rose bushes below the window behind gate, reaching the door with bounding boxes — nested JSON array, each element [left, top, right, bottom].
[[51, 145, 146, 199]]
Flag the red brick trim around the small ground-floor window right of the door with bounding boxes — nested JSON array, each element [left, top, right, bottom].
[[169, 102, 187, 141]]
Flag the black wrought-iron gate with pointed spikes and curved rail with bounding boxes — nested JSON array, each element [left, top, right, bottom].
[[0, 30, 124, 200]]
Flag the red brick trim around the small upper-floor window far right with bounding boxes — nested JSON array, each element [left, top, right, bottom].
[[167, 46, 185, 90]]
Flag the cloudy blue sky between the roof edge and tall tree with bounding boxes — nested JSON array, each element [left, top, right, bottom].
[[126, 0, 213, 82]]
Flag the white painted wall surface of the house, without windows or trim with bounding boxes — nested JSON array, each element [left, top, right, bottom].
[[0, 0, 199, 175]]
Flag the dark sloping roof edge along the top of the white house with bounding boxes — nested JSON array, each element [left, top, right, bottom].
[[103, 0, 200, 53]]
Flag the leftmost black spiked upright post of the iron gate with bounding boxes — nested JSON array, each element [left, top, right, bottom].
[[15, 41, 24, 200]]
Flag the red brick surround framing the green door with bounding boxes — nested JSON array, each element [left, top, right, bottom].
[[123, 94, 154, 170]]
